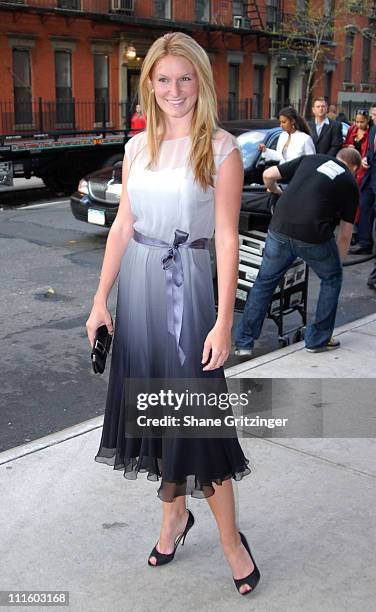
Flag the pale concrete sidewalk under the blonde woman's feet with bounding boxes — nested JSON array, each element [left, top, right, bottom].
[[0, 314, 376, 612]]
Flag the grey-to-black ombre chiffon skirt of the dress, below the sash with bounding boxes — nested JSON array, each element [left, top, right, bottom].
[[95, 240, 251, 502]]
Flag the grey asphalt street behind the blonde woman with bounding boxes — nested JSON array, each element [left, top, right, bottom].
[[0, 200, 376, 452]]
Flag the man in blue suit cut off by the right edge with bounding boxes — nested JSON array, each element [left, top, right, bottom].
[[350, 105, 376, 268]]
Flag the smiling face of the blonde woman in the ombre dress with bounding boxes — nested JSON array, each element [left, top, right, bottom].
[[151, 55, 198, 118]]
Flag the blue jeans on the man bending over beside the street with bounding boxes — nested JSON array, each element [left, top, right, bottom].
[[235, 230, 342, 348]]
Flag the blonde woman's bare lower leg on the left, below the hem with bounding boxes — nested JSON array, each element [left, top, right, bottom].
[[150, 495, 188, 565]]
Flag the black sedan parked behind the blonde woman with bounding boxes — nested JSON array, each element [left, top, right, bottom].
[[71, 120, 281, 227]]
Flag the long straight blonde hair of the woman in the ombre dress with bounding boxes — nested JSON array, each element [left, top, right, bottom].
[[139, 32, 218, 191]]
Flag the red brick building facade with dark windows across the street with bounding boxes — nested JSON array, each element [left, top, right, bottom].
[[0, 0, 376, 133]]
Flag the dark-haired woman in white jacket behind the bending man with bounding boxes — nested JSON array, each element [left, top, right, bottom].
[[259, 106, 316, 164]]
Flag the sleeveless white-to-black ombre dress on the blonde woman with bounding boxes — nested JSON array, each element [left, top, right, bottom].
[[95, 129, 250, 501]]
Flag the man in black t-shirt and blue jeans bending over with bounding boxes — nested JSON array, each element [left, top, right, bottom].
[[235, 148, 361, 355]]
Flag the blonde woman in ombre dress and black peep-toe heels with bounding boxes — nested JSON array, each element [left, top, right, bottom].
[[86, 32, 259, 595]]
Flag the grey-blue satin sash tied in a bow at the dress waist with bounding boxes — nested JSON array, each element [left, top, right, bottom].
[[133, 230, 209, 365]]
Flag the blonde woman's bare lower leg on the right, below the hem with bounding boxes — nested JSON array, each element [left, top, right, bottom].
[[206, 479, 254, 593]]
